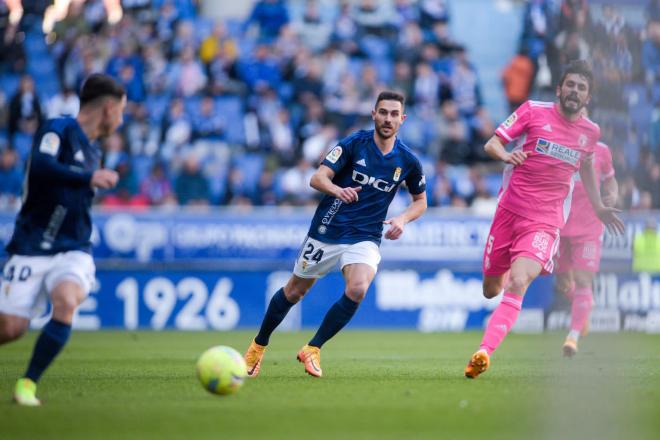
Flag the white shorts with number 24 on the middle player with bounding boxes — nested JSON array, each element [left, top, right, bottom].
[[293, 237, 380, 278]]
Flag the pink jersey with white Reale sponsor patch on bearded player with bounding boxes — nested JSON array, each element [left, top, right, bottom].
[[495, 101, 600, 228]]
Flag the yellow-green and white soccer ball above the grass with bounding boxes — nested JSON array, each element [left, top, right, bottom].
[[197, 345, 247, 394]]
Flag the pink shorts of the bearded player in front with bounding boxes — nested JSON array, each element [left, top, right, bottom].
[[482, 207, 559, 276]]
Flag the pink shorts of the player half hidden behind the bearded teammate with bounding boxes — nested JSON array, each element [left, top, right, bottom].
[[555, 235, 602, 273]]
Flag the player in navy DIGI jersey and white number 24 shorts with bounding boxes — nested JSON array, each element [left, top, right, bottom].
[[245, 92, 426, 377]]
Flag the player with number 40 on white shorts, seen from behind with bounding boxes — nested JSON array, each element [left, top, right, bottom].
[[0, 74, 126, 406]]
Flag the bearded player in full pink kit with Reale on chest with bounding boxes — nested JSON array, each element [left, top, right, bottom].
[[465, 60, 624, 378]]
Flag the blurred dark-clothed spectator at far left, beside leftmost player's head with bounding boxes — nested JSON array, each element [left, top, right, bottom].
[[8, 75, 42, 142]]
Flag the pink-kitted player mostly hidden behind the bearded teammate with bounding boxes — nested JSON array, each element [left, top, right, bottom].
[[555, 142, 619, 357]]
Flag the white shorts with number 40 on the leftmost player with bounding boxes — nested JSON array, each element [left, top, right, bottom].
[[0, 251, 96, 319]]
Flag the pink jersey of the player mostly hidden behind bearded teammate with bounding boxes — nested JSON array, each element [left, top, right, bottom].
[[561, 142, 614, 237]]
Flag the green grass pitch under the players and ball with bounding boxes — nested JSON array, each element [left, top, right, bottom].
[[0, 331, 660, 440]]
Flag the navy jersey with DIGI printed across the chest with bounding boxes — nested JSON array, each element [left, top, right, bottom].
[[308, 130, 426, 244]]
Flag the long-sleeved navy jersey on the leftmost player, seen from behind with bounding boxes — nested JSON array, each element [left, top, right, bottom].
[[7, 118, 101, 255]]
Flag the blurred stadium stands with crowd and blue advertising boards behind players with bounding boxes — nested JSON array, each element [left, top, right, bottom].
[[0, 0, 660, 331]]
